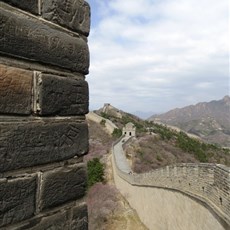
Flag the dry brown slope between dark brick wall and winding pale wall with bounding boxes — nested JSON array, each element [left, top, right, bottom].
[[84, 119, 146, 230]]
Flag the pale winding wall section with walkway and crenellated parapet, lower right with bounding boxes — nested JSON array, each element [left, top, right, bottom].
[[112, 139, 230, 230]]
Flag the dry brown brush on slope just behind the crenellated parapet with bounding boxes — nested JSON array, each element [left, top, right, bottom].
[[125, 135, 230, 173]]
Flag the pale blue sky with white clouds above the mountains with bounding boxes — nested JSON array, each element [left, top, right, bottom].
[[86, 0, 230, 116]]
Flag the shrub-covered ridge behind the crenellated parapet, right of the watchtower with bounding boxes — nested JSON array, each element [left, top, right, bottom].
[[95, 103, 230, 173]]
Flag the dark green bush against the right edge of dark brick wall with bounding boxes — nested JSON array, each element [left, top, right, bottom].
[[87, 158, 104, 188]]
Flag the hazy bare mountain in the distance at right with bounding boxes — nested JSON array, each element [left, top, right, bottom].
[[148, 96, 230, 147]]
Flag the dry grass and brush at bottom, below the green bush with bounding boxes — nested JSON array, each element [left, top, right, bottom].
[[87, 183, 147, 230]]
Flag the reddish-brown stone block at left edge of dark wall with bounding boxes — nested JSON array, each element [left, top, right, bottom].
[[0, 64, 33, 115]]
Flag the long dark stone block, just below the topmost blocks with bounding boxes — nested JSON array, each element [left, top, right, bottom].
[[0, 3, 89, 74]]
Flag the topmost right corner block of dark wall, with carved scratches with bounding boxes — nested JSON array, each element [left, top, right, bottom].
[[42, 0, 90, 36]]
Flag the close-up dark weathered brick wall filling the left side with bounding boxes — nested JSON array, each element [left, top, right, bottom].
[[0, 0, 90, 229]]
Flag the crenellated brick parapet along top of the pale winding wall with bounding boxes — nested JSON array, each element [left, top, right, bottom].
[[113, 140, 230, 229]]
